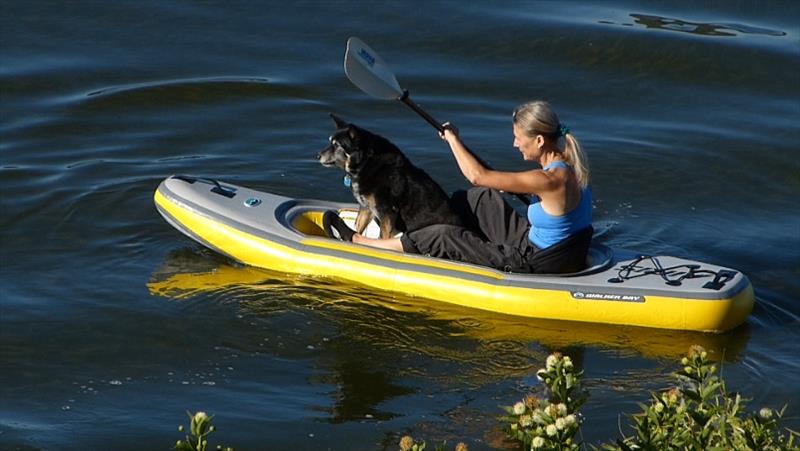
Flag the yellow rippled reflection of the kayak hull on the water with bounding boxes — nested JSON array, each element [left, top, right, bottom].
[[148, 249, 749, 364]]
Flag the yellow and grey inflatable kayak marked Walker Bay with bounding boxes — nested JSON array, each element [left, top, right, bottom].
[[154, 175, 754, 333]]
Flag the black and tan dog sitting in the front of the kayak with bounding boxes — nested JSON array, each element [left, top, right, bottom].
[[317, 114, 464, 238]]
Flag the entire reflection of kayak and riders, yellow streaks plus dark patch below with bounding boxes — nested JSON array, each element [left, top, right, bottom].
[[147, 247, 750, 424]]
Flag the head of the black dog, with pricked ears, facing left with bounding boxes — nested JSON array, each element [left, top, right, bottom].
[[317, 114, 371, 175]]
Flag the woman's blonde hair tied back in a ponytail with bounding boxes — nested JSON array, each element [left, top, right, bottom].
[[512, 100, 589, 188]]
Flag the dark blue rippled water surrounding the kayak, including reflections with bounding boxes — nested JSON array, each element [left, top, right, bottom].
[[0, 0, 800, 449]]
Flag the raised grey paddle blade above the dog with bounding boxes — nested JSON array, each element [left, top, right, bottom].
[[344, 36, 403, 100]]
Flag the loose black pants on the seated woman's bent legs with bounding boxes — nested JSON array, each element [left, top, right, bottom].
[[400, 188, 537, 272]]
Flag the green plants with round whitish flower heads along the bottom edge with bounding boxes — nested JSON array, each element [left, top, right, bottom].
[[175, 346, 800, 451]]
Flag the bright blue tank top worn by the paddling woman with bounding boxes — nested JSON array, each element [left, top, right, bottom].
[[528, 160, 592, 249]]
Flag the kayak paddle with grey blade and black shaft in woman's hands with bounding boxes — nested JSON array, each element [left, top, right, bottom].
[[344, 36, 530, 205]]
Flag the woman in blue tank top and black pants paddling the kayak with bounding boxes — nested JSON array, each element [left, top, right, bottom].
[[323, 101, 592, 273]]
